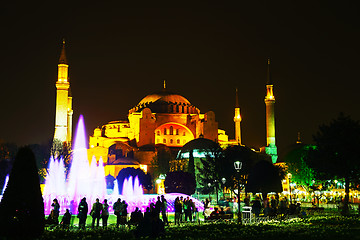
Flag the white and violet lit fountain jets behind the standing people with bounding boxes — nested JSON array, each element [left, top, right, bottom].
[[43, 116, 203, 215]]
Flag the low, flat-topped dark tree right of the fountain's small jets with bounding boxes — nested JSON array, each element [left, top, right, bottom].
[[164, 171, 196, 195]]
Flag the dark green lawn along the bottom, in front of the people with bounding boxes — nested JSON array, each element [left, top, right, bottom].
[[40, 216, 360, 240]]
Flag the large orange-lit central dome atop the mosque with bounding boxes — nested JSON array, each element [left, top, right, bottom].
[[129, 91, 200, 114]]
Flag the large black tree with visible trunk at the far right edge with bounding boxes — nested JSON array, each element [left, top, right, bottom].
[[305, 113, 360, 215]]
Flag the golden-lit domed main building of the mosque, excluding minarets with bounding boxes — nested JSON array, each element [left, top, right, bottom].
[[88, 84, 222, 176]]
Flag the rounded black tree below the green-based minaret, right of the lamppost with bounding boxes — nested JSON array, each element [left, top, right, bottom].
[[245, 160, 282, 199]]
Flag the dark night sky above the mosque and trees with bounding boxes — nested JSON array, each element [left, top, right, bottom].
[[0, 0, 360, 156]]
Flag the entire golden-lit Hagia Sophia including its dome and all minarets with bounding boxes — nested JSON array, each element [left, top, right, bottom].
[[54, 41, 277, 182]]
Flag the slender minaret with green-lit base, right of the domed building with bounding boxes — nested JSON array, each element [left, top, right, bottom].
[[265, 58, 277, 163]]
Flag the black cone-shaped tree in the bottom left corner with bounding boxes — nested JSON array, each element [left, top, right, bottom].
[[0, 148, 45, 239]]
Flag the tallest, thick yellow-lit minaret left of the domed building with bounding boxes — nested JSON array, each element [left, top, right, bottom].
[[54, 40, 73, 145]]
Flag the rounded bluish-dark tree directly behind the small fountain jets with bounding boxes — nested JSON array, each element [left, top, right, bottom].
[[116, 167, 153, 194]]
